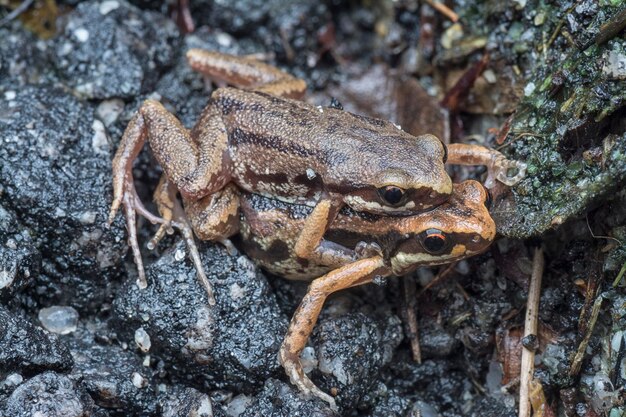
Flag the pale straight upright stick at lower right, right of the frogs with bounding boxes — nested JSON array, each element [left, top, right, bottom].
[[518, 248, 544, 417]]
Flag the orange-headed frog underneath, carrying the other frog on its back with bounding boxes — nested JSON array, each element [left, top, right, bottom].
[[154, 179, 496, 408]]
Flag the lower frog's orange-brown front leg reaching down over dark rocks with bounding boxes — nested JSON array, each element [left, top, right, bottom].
[[279, 256, 389, 408]]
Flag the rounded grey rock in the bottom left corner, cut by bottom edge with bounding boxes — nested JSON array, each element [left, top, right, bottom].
[[0, 372, 95, 417]]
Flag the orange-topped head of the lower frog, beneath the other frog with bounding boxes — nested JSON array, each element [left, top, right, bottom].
[[391, 180, 496, 275]]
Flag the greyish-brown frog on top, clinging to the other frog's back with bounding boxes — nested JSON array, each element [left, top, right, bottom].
[[108, 49, 525, 303]]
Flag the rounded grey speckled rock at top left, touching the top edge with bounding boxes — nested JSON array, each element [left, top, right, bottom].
[[50, 0, 180, 99]]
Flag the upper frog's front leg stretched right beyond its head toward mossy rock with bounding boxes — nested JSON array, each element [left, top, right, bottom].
[[447, 143, 526, 188]]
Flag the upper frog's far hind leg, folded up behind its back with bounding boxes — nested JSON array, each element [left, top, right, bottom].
[[187, 49, 306, 99]]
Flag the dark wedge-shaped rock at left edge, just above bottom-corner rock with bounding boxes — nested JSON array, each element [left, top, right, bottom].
[[0, 306, 73, 376]]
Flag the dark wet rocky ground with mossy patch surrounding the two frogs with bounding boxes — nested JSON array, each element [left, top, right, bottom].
[[0, 0, 626, 417]]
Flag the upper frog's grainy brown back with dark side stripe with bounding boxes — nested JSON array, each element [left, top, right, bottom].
[[212, 88, 446, 200]]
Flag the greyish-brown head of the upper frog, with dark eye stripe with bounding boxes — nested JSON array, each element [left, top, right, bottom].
[[344, 135, 452, 215]]
